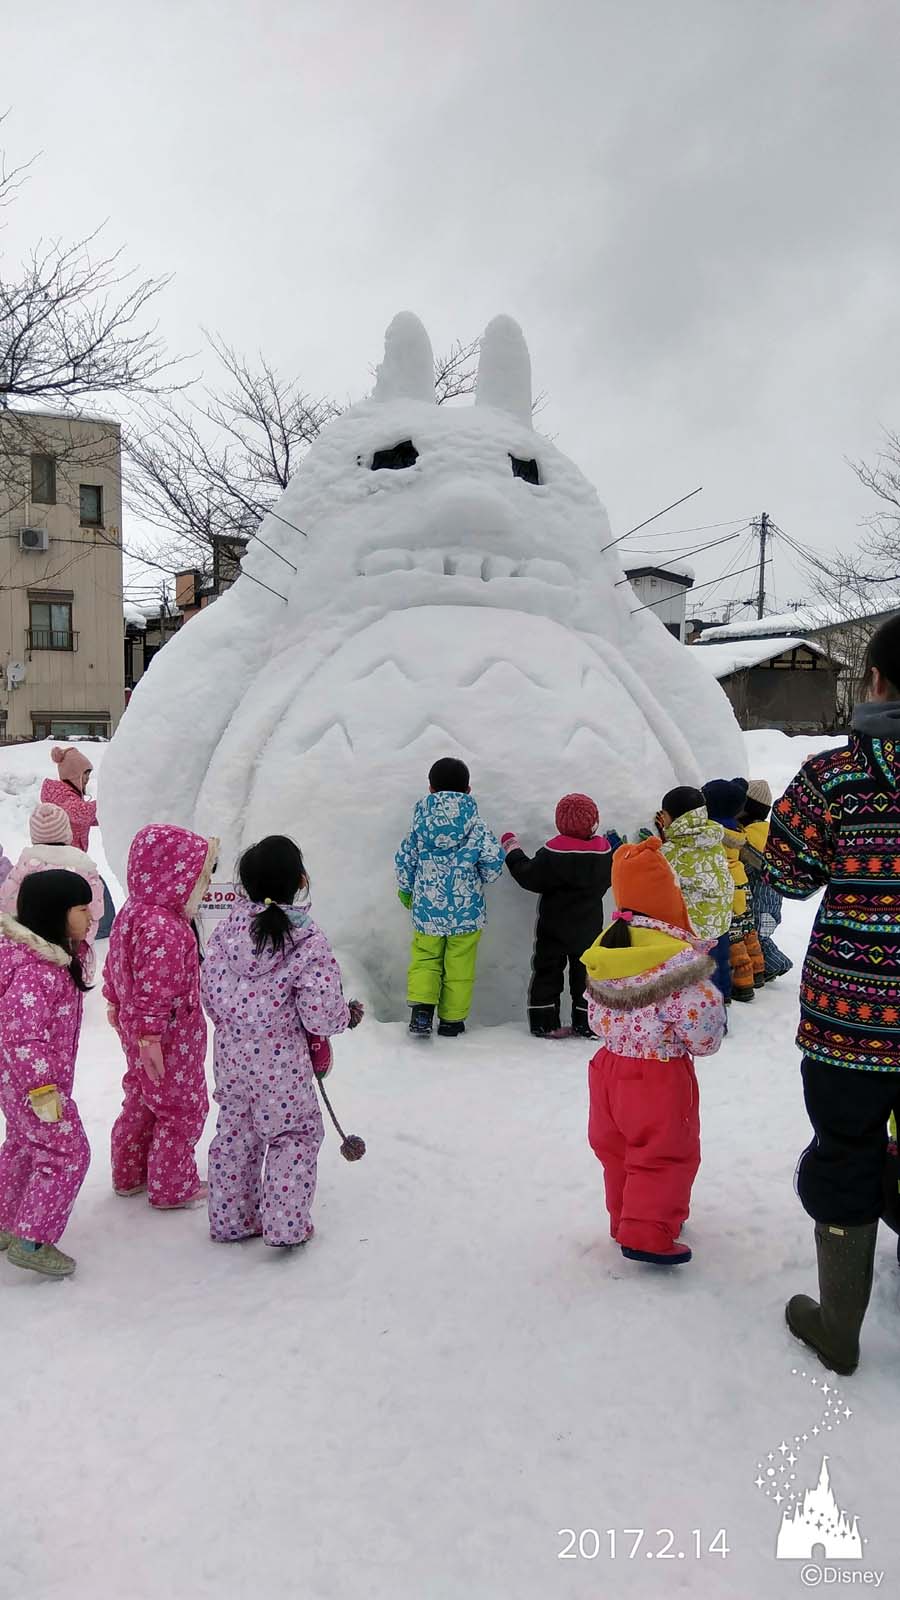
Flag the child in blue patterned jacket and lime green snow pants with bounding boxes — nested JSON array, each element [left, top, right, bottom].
[[396, 755, 504, 1038]]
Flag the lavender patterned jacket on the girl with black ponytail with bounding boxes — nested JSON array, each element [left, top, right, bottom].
[[200, 901, 351, 1083]]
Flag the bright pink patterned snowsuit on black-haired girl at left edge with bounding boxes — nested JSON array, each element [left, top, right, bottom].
[[0, 917, 91, 1245]]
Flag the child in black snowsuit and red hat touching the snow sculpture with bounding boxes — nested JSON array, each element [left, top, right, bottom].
[[501, 795, 613, 1038]]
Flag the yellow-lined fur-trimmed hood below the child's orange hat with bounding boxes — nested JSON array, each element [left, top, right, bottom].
[[581, 917, 714, 1011]]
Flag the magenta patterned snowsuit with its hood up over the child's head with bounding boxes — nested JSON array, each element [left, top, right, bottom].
[[102, 824, 211, 1208]]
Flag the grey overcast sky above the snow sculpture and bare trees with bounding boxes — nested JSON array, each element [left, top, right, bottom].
[[7, 0, 900, 617]]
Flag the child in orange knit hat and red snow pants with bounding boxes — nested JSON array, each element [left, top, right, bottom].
[[583, 838, 725, 1267]]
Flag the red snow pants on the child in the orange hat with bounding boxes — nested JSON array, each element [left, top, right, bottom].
[[588, 1050, 700, 1251]]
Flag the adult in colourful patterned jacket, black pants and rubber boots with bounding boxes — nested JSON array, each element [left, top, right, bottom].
[[765, 618, 900, 1376]]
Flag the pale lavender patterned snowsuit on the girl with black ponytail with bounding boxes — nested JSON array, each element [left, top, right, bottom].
[[202, 901, 351, 1245]]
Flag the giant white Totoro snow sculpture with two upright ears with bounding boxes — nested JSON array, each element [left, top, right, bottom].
[[99, 314, 745, 1021]]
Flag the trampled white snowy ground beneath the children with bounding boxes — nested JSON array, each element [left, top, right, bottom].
[[0, 734, 900, 1600]]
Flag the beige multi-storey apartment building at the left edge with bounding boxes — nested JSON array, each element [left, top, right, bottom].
[[0, 411, 125, 741]]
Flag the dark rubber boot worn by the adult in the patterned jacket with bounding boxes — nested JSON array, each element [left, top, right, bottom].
[[785, 1222, 878, 1378]]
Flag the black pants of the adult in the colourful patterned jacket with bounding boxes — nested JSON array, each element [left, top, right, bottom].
[[798, 1058, 900, 1227]]
